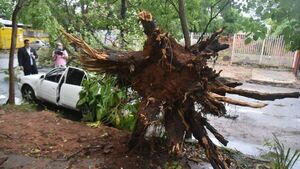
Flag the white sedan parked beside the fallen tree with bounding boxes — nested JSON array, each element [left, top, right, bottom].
[[18, 67, 87, 110]]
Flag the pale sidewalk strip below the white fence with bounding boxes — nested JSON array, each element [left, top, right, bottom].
[[214, 64, 300, 89]]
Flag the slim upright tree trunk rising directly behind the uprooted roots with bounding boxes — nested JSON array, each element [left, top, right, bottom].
[[178, 0, 191, 48]]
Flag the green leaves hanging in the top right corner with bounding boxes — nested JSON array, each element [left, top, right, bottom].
[[236, 0, 300, 50]]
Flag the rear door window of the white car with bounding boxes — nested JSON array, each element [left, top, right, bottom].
[[66, 68, 85, 86]]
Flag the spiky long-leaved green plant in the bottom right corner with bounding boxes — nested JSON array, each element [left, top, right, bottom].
[[263, 135, 300, 169]]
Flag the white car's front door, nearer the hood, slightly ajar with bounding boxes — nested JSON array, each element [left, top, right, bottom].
[[36, 68, 65, 104]]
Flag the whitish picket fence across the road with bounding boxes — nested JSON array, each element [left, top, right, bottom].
[[231, 34, 295, 68]]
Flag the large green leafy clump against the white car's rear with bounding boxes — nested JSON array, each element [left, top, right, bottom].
[[77, 74, 138, 131]]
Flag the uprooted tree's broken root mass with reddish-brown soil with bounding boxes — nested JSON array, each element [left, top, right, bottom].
[[62, 11, 300, 169]]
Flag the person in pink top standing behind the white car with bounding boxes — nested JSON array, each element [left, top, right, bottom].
[[52, 43, 68, 67]]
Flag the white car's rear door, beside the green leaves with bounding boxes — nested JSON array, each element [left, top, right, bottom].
[[59, 67, 86, 110]]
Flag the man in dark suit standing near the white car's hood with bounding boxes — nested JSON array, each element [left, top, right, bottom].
[[18, 39, 38, 76]]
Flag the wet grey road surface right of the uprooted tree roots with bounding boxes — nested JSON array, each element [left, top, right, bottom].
[[208, 83, 300, 168]]
